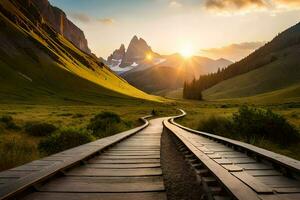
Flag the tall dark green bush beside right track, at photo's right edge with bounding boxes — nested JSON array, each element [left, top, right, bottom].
[[233, 106, 299, 145]]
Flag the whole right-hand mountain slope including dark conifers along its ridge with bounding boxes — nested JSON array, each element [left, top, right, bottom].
[[188, 23, 300, 101]]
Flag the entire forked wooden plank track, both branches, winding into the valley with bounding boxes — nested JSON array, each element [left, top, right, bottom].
[[0, 111, 300, 200]]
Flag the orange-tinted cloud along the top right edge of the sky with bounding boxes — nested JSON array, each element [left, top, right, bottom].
[[204, 0, 300, 13]]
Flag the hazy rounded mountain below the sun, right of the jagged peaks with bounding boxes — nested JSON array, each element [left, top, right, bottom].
[[121, 54, 232, 93]]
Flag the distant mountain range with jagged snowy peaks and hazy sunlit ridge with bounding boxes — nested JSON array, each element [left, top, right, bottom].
[[107, 36, 232, 93]]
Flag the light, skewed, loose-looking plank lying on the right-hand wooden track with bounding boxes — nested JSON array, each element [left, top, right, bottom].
[[232, 172, 273, 193]]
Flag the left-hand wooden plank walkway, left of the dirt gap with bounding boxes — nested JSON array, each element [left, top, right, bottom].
[[0, 118, 166, 200]]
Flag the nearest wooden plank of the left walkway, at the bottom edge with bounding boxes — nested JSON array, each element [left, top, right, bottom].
[[21, 192, 167, 200]]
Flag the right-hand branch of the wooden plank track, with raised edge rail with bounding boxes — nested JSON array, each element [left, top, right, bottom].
[[164, 111, 300, 200]]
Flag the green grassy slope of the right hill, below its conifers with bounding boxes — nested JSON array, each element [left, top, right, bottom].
[[203, 45, 300, 102]]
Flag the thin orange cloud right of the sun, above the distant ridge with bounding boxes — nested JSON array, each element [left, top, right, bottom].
[[201, 42, 265, 61]]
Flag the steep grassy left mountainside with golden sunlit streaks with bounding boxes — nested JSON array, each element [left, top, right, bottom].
[[0, 0, 160, 104]]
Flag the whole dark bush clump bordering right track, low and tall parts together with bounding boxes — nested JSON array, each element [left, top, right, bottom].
[[198, 106, 300, 145]]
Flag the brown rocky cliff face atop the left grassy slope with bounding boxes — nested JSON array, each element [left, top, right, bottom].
[[26, 0, 91, 54]]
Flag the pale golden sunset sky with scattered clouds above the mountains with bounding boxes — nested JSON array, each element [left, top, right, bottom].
[[50, 0, 300, 61]]
